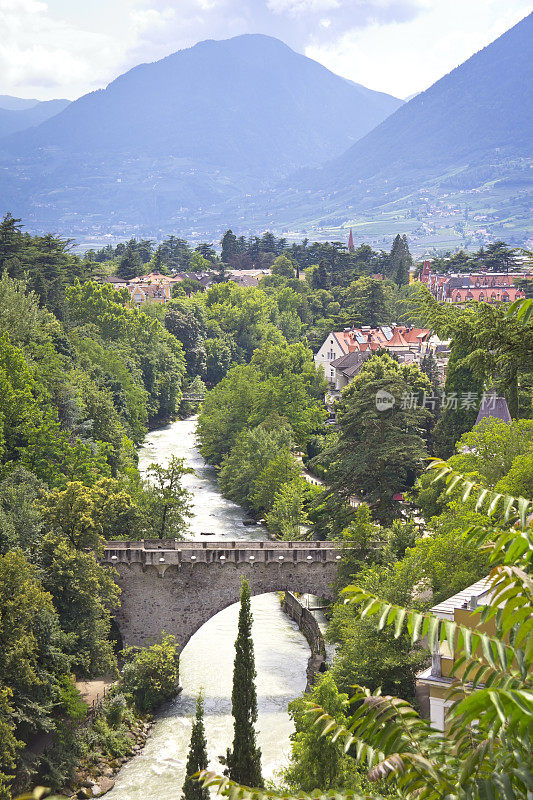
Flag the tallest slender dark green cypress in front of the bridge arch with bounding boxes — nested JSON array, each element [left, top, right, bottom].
[[226, 579, 263, 787]]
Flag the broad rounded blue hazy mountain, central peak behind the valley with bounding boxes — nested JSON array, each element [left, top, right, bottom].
[[0, 35, 402, 232]]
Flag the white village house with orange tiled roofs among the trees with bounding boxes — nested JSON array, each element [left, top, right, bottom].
[[315, 324, 443, 392]]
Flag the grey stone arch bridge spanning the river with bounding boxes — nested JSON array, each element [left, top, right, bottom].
[[103, 539, 341, 649]]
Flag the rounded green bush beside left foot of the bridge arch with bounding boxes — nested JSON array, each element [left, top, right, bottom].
[[120, 635, 179, 711]]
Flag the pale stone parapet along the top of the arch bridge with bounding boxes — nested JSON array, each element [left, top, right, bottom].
[[103, 539, 341, 568]]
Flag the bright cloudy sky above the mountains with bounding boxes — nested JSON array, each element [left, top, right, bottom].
[[0, 0, 533, 100]]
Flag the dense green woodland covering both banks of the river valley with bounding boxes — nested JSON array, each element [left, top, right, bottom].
[[0, 212, 533, 800]]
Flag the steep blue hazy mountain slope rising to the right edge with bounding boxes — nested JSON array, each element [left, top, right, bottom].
[[256, 14, 533, 241]]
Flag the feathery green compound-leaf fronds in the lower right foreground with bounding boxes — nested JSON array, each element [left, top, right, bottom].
[[200, 462, 533, 800]]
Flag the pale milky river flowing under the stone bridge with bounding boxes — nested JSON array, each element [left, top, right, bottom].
[[108, 417, 309, 800]]
